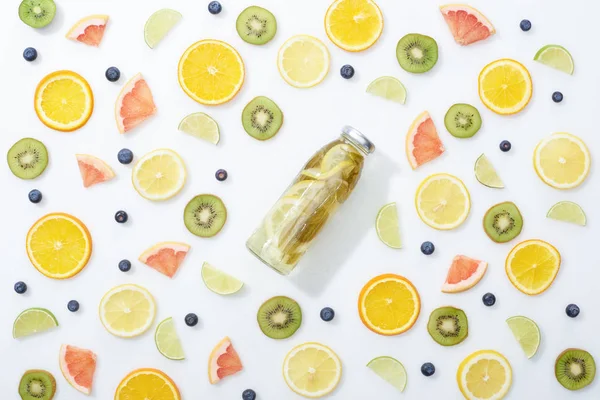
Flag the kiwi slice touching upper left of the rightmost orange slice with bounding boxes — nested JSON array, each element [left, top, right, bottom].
[[483, 201, 523, 243]]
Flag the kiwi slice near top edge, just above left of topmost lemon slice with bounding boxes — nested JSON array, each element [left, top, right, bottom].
[[235, 6, 277, 45]]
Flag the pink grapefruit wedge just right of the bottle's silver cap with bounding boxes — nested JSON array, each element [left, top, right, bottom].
[[406, 111, 445, 169]]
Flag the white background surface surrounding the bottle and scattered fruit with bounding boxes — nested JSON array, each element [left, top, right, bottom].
[[0, 0, 600, 400]]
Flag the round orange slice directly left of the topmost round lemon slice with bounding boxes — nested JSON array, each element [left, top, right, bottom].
[[178, 40, 245, 105]]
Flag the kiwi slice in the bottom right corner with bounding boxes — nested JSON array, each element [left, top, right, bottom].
[[554, 349, 596, 390]]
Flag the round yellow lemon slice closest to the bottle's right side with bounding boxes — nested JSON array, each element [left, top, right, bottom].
[[415, 174, 471, 230]]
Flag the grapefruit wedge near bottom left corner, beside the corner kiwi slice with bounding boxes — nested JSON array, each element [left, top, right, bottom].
[[59, 344, 96, 395]]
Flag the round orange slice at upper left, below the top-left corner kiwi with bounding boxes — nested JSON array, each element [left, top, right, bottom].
[[34, 71, 94, 132]]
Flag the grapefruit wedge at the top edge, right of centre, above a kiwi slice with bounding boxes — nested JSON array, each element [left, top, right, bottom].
[[440, 4, 496, 46]]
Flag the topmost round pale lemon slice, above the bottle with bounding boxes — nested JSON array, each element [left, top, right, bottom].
[[277, 35, 329, 88]]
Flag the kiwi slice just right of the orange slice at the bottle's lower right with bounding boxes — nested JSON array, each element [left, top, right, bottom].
[[427, 306, 469, 346]]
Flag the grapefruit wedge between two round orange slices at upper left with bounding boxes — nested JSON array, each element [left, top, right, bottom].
[[115, 74, 156, 133]]
